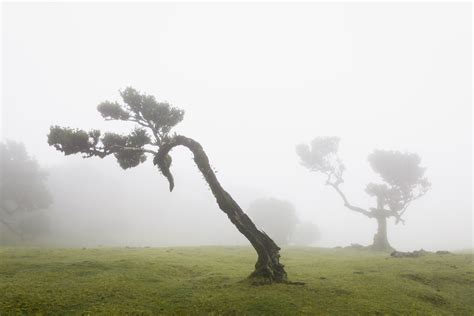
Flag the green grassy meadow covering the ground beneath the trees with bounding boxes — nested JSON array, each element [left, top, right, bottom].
[[0, 247, 474, 315]]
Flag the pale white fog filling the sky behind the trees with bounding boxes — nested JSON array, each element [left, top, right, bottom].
[[1, 3, 473, 250]]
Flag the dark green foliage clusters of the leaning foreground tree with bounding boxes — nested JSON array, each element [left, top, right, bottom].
[[48, 87, 184, 169]]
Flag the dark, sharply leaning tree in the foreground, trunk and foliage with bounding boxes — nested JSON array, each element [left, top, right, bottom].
[[48, 88, 287, 282]]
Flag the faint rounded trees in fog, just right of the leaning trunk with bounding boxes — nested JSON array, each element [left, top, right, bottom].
[[247, 198, 319, 246]]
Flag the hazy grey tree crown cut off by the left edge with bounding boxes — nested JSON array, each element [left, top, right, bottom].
[[0, 141, 52, 240]]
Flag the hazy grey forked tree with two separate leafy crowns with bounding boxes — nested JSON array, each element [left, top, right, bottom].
[[296, 137, 431, 251]]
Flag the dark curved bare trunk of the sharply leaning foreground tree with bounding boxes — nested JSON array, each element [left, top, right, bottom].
[[154, 135, 287, 282]]
